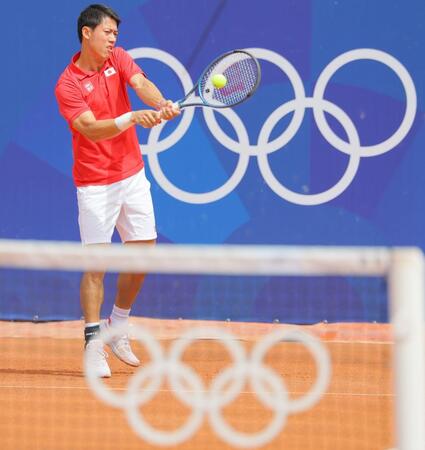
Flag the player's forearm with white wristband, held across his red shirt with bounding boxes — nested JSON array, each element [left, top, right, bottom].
[[72, 110, 161, 142]]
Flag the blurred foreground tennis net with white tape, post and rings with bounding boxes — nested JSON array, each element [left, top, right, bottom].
[[0, 241, 425, 450]]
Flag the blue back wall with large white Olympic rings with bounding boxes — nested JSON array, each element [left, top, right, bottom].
[[0, 0, 425, 322]]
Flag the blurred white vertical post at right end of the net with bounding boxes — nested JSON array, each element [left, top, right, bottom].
[[388, 248, 425, 450]]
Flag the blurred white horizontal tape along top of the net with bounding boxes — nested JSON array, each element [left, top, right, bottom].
[[0, 240, 391, 276]]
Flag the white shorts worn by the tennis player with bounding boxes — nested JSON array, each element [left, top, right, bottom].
[[77, 169, 157, 244]]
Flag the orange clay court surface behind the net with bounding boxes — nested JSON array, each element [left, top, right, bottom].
[[0, 318, 395, 450]]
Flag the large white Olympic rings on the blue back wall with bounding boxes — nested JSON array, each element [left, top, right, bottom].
[[129, 47, 417, 205]]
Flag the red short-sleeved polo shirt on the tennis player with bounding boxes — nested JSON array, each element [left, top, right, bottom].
[[55, 47, 144, 186]]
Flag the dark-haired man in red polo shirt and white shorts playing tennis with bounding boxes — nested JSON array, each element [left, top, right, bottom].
[[55, 5, 179, 377]]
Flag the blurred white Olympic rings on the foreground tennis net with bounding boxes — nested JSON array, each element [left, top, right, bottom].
[[85, 327, 331, 448]]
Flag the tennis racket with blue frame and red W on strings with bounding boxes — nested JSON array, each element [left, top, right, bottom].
[[166, 50, 261, 109]]
